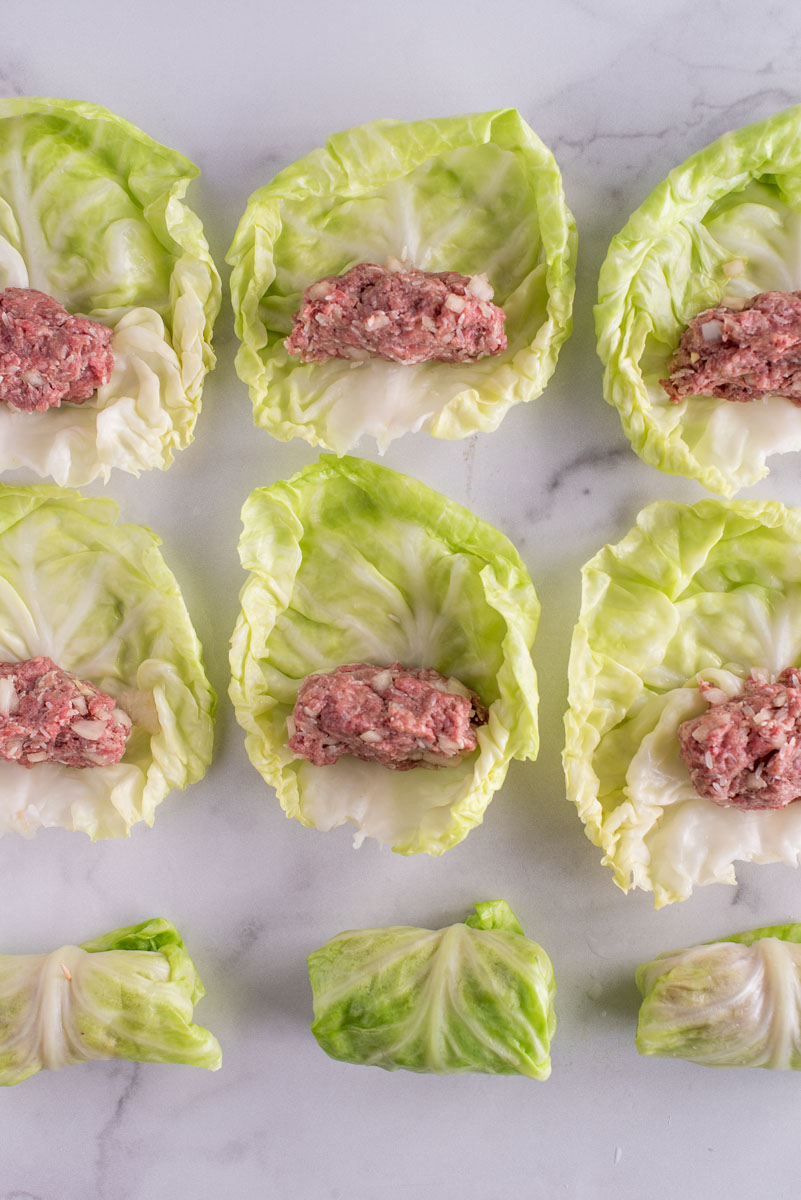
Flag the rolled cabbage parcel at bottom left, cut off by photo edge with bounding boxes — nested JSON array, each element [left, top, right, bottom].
[[0, 918, 222, 1087]]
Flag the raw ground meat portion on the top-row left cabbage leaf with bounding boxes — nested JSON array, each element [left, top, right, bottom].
[[0, 288, 114, 413]]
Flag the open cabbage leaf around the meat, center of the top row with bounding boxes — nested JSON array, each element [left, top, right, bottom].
[[228, 109, 576, 454]]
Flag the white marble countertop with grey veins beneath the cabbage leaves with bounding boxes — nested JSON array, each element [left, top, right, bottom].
[[0, 0, 801, 1200]]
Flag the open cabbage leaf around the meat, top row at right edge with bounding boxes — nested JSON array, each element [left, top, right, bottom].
[[596, 107, 801, 496]]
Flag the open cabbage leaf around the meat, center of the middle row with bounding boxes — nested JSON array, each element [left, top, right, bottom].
[[230, 455, 540, 854]]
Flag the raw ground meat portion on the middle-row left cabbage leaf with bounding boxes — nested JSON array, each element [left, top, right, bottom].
[[0, 658, 131, 767]]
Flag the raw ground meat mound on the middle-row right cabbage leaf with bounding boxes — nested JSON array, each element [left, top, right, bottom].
[[679, 667, 801, 809]]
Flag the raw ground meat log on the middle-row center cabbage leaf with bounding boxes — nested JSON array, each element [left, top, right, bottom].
[[288, 662, 488, 770]]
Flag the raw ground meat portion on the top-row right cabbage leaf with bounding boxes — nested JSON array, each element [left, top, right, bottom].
[[660, 292, 801, 404]]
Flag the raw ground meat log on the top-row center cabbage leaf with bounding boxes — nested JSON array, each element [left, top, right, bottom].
[[284, 263, 506, 364]]
